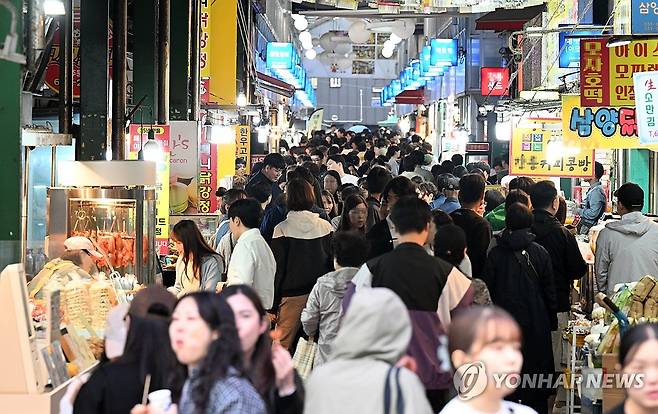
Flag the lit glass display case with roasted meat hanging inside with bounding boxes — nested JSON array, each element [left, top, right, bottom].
[[47, 186, 156, 284]]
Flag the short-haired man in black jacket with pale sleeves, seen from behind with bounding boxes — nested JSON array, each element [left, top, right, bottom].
[[345, 196, 473, 411]]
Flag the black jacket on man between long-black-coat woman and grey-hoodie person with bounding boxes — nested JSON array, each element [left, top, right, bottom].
[[532, 210, 587, 312]]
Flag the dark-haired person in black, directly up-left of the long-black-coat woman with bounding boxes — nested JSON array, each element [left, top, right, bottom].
[[451, 174, 491, 279]]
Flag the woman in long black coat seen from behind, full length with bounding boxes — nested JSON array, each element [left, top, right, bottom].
[[483, 203, 557, 414]]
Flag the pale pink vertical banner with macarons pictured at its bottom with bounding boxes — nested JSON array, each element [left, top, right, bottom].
[[169, 121, 199, 214]]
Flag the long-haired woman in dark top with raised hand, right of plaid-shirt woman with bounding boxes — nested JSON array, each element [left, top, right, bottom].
[[221, 285, 304, 414]]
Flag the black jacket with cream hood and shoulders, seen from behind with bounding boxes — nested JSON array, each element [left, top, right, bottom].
[[271, 210, 333, 309]]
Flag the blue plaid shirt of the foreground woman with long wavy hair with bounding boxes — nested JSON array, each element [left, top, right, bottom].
[[178, 369, 267, 414]]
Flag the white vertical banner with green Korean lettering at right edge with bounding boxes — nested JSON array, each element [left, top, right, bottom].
[[633, 72, 658, 144]]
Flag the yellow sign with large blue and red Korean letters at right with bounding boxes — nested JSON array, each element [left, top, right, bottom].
[[562, 95, 658, 149]]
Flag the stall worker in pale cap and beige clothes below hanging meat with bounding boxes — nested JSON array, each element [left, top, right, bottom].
[[27, 236, 103, 299]]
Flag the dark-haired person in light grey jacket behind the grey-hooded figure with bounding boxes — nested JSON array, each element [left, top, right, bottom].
[[301, 231, 368, 367]]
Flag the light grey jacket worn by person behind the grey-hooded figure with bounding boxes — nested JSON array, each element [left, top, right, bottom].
[[302, 267, 359, 366]]
